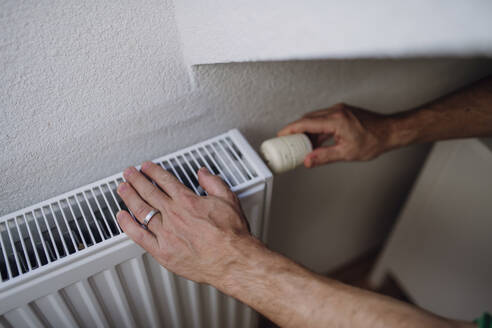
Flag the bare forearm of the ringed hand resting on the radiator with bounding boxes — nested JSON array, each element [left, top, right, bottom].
[[217, 237, 467, 327]]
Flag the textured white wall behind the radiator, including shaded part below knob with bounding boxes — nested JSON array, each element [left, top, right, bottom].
[[0, 0, 492, 271]]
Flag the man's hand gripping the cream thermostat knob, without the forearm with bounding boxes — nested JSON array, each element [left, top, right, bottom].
[[278, 104, 389, 167]]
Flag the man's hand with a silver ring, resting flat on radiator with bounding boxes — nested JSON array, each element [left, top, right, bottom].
[[117, 162, 259, 285]]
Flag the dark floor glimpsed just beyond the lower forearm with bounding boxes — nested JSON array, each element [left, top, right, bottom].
[[259, 248, 413, 328]]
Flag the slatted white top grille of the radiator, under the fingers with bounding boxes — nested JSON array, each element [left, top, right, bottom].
[[0, 130, 261, 286]]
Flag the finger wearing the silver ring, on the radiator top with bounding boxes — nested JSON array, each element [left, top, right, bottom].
[[118, 182, 162, 231]]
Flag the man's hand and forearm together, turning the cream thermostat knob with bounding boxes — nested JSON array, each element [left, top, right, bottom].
[[278, 77, 492, 167]]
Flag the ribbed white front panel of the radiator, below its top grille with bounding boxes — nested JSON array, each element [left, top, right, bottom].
[[3, 254, 257, 328]]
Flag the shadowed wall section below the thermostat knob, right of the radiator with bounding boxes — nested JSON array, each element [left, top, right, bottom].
[[268, 145, 430, 273]]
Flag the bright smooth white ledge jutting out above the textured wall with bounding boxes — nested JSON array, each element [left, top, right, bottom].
[[176, 0, 492, 64]]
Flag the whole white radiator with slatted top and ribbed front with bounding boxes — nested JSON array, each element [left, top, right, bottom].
[[0, 130, 272, 327]]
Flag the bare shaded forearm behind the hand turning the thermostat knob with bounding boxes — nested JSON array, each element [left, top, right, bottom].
[[385, 77, 492, 149]]
